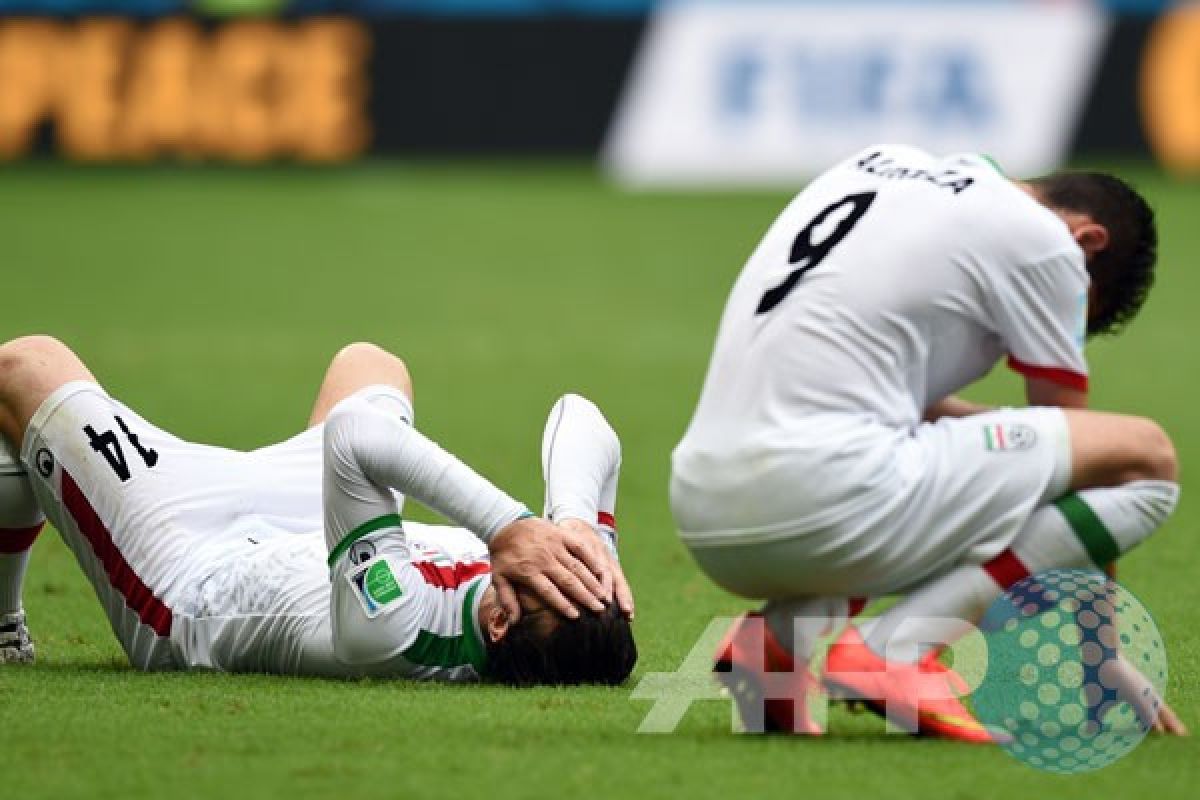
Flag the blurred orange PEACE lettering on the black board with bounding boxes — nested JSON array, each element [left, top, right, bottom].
[[0, 18, 371, 162]]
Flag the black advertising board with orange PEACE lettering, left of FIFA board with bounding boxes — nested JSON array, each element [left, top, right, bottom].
[[0, 17, 642, 163]]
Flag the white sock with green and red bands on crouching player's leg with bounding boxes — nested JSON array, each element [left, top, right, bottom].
[[865, 481, 1180, 661]]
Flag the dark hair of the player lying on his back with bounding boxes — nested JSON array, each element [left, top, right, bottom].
[[484, 603, 637, 686]]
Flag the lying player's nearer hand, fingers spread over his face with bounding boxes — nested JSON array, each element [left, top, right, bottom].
[[488, 517, 612, 620]]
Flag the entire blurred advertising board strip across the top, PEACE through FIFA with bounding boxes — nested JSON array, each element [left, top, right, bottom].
[[0, 0, 1200, 169]]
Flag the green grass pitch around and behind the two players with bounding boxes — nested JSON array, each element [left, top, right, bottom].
[[0, 163, 1200, 800]]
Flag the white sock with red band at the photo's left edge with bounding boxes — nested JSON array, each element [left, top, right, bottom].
[[0, 439, 46, 614]]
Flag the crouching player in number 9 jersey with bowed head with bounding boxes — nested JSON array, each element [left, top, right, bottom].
[[671, 146, 1182, 741]]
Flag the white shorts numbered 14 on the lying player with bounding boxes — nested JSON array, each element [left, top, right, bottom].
[[22, 381, 386, 669]]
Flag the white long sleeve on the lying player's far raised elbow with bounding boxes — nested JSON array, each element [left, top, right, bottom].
[[541, 395, 620, 555]]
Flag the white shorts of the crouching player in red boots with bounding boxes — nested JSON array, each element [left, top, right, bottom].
[[671, 408, 1070, 599]]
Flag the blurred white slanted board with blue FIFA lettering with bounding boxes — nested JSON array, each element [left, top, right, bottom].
[[605, 0, 1110, 185]]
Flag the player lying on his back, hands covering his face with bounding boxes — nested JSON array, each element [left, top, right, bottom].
[[0, 337, 636, 685]]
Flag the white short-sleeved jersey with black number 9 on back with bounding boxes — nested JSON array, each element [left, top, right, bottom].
[[673, 145, 1088, 481]]
